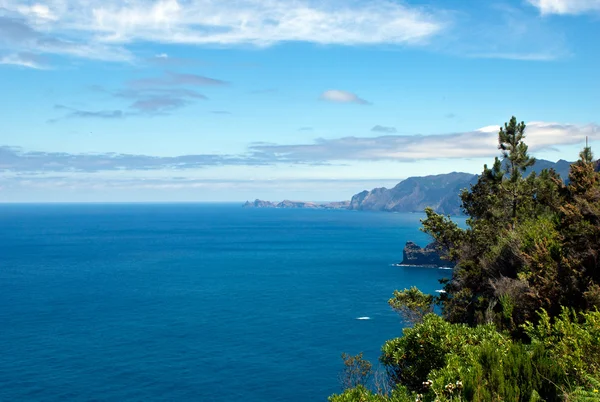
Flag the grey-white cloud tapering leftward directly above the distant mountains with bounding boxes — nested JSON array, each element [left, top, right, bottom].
[[251, 122, 600, 163]]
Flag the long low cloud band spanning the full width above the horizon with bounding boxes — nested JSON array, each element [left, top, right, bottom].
[[0, 120, 600, 172]]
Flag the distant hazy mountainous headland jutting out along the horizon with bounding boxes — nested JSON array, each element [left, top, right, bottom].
[[243, 159, 571, 215]]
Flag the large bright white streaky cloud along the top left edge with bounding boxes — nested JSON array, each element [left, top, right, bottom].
[[0, 0, 445, 52]]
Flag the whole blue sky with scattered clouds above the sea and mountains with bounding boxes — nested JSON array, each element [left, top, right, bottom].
[[0, 0, 600, 202]]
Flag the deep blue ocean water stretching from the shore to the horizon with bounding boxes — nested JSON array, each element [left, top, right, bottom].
[[0, 204, 450, 402]]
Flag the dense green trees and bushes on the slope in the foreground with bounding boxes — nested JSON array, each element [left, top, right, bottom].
[[329, 117, 600, 402]]
